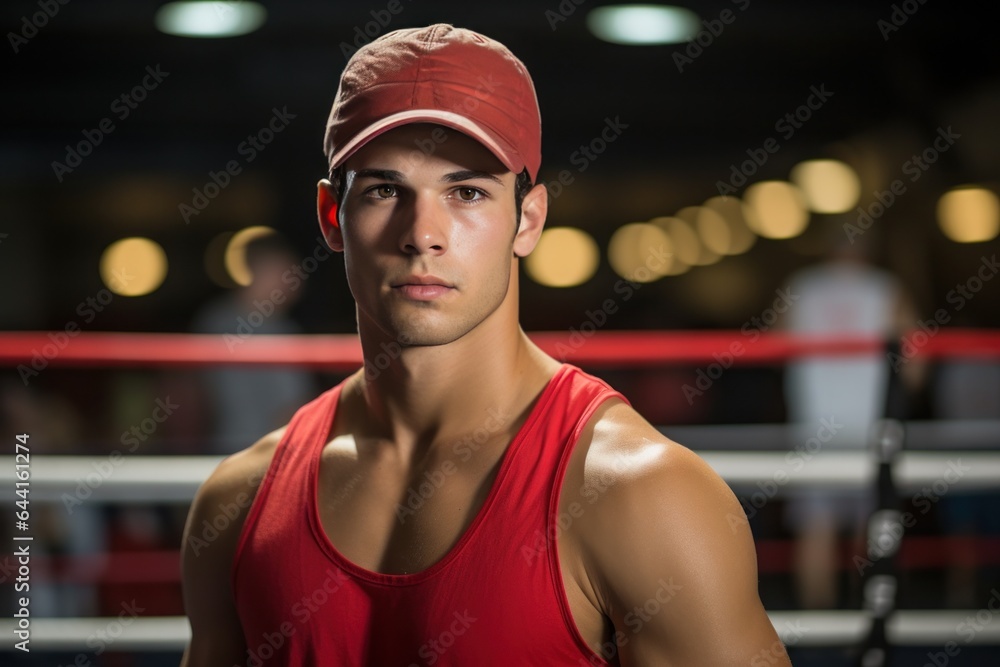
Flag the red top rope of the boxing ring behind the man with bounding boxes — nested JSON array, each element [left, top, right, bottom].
[[0, 327, 1000, 372]]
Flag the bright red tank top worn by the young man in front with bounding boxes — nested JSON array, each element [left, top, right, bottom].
[[233, 364, 625, 667]]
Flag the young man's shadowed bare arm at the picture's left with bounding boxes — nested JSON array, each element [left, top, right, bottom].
[[181, 431, 281, 667]]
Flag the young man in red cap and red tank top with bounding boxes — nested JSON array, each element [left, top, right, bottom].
[[183, 25, 789, 667]]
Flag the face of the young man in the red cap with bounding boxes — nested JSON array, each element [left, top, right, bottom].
[[340, 124, 516, 345]]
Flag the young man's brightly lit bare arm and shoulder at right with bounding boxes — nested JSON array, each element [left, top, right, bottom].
[[582, 405, 791, 667]]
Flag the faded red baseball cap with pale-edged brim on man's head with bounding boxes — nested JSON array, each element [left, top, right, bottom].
[[323, 23, 542, 182]]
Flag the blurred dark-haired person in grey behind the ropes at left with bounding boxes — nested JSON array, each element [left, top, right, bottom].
[[193, 234, 317, 454]]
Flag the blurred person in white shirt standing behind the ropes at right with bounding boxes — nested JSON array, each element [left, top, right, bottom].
[[782, 226, 916, 609]]
